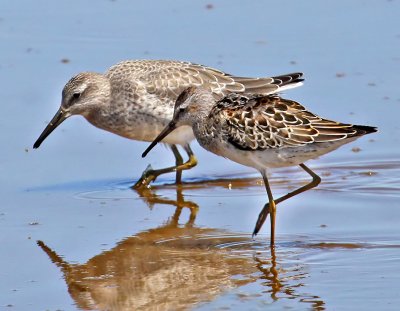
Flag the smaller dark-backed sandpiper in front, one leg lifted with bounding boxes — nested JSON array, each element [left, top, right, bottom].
[[143, 87, 377, 246]]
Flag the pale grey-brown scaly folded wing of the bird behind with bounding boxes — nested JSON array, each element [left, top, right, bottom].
[[109, 60, 303, 100]]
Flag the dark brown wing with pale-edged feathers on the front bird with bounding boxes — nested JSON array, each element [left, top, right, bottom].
[[216, 94, 357, 150]]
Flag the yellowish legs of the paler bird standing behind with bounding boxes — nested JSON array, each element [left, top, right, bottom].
[[132, 144, 197, 189]]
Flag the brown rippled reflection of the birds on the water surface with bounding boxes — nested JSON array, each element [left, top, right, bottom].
[[37, 189, 324, 310]]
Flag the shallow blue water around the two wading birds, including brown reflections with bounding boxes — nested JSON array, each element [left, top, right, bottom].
[[0, 0, 400, 310]]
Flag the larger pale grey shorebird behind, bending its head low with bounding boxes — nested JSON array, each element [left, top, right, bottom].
[[33, 60, 303, 188]]
